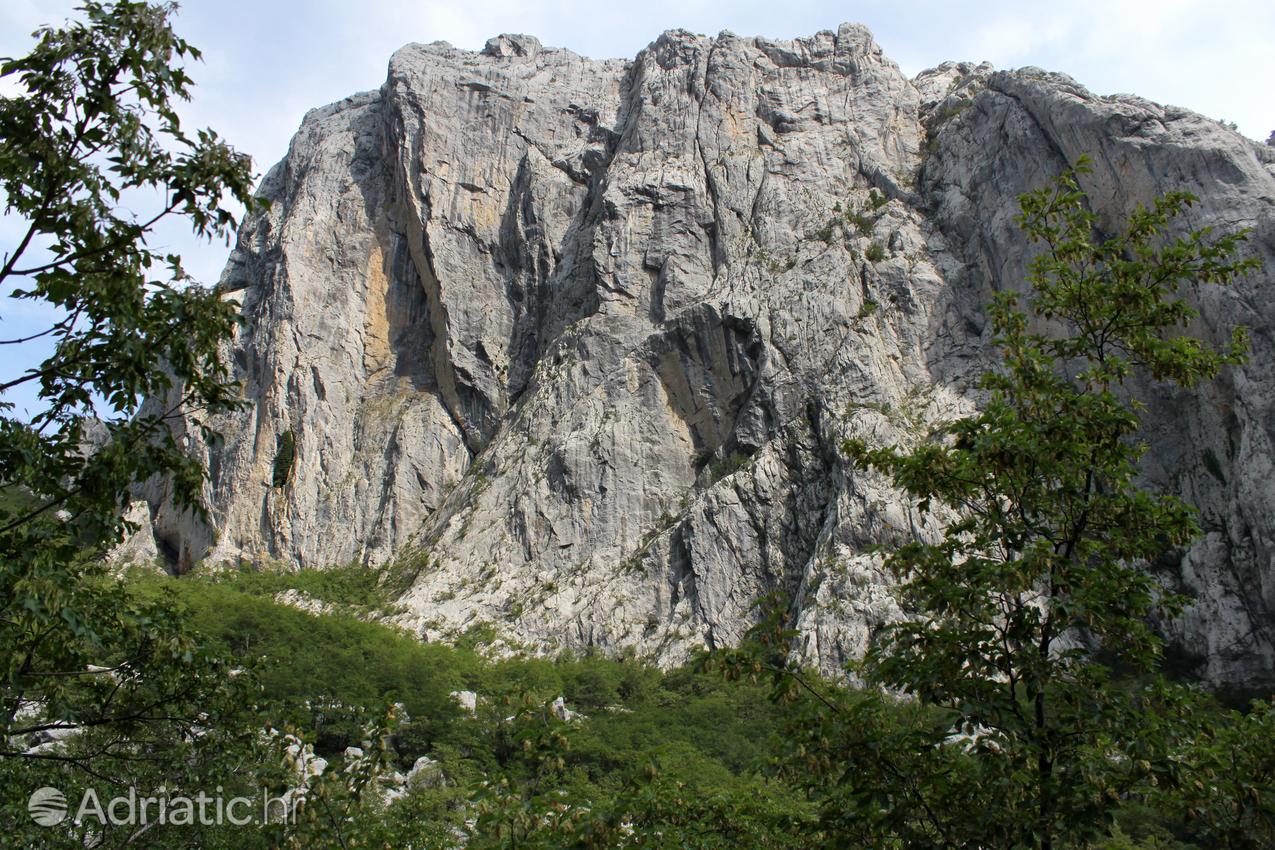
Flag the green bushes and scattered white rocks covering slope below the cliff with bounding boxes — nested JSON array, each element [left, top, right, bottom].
[[124, 572, 810, 847]]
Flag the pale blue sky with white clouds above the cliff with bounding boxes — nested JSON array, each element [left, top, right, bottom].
[[0, 0, 1275, 417]]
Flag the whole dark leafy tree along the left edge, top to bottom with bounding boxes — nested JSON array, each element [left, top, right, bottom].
[[0, 0, 258, 805]]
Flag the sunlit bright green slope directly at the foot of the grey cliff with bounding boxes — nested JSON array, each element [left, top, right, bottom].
[[135, 570, 780, 785]]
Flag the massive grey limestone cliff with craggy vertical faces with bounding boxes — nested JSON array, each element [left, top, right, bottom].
[[137, 25, 1275, 683]]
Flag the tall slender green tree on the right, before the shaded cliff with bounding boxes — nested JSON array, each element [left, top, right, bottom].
[[842, 162, 1256, 850]]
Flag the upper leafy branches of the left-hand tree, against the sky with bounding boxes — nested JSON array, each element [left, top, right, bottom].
[[0, 3, 258, 552]]
